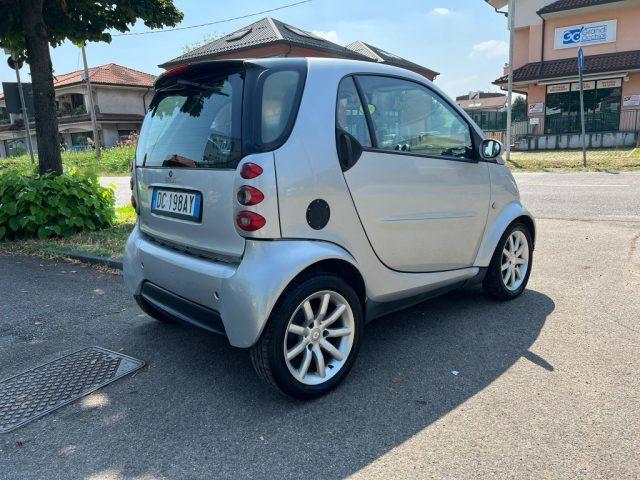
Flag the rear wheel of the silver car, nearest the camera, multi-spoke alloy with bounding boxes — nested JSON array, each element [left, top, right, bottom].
[[250, 273, 363, 400]]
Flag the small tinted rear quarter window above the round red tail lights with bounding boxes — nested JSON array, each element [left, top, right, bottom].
[[261, 70, 300, 144]]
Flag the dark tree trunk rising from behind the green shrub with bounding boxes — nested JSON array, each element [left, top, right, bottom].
[[20, 0, 62, 174]]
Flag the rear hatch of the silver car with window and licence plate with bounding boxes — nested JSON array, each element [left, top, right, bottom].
[[136, 62, 245, 258]]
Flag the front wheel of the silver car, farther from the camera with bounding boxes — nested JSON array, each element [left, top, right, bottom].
[[482, 223, 533, 300]]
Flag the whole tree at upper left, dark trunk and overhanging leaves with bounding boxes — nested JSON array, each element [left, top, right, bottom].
[[0, 0, 182, 174]]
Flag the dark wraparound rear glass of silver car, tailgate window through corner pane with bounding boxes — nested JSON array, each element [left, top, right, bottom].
[[136, 59, 306, 169]]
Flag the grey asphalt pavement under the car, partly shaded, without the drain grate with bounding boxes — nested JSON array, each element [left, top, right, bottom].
[[0, 174, 640, 480]]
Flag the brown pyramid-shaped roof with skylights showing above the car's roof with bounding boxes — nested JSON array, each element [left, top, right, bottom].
[[159, 17, 439, 80]]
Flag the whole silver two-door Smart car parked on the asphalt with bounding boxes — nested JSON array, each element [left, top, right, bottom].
[[124, 58, 535, 399]]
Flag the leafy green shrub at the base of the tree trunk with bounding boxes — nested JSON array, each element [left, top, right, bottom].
[[0, 169, 115, 240]]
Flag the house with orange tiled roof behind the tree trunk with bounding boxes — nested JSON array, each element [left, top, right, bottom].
[[0, 63, 155, 157]]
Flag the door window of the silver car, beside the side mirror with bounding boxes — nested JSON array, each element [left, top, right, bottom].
[[358, 75, 476, 159]]
